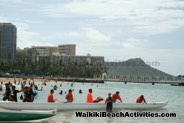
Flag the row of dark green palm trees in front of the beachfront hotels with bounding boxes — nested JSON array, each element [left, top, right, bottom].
[[0, 59, 107, 78]]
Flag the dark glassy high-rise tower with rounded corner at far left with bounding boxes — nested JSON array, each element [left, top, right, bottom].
[[0, 23, 17, 61]]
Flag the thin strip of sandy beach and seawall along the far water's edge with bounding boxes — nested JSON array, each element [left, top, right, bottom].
[[0, 77, 184, 86]]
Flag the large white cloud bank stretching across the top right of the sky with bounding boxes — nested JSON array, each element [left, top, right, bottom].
[[44, 0, 184, 35]]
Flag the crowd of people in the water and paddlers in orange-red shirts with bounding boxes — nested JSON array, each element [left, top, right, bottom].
[[0, 81, 146, 110]]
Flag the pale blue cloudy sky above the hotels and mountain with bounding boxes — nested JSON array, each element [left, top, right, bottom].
[[0, 0, 184, 75]]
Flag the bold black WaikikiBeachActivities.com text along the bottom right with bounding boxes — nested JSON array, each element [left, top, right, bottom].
[[75, 112, 176, 117]]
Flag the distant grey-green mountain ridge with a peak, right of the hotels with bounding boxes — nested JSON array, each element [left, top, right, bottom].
[[105, 58, 173, 77]]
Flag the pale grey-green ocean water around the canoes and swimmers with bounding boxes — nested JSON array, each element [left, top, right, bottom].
[[0, 82, 184, 123]]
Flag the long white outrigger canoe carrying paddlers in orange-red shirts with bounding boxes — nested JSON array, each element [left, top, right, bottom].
[[0, 101, 168, 111]]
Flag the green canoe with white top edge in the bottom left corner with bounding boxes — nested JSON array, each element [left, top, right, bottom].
[[0, 109, 56, 121]]
